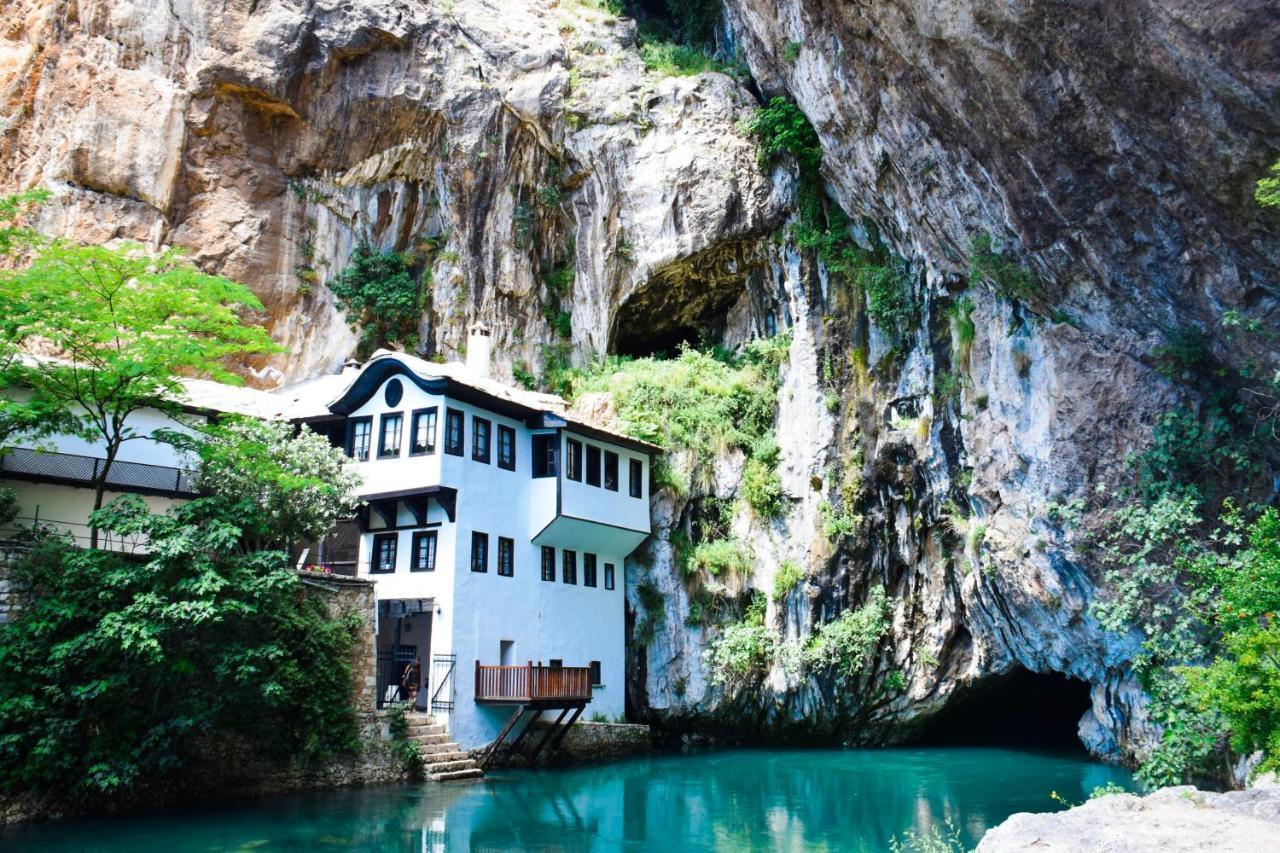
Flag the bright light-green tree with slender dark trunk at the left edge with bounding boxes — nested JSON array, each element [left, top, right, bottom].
[[0, 241, 279, 546]]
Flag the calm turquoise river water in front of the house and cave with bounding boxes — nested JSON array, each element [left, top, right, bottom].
[[0, 747, 1133, 853]]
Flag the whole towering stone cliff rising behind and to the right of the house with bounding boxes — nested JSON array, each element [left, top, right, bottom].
[[0, 0, 1280, 761]]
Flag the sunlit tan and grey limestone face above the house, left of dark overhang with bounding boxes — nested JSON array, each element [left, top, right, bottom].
[[0, 0, 787, 386]]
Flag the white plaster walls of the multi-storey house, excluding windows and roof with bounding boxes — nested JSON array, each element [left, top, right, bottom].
[[352, 371, 649, 748]]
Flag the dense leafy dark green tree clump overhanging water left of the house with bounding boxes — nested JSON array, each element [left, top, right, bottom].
[[0, 425, 358, 798]]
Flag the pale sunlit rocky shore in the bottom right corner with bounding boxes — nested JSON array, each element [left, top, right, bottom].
[[975, 779, 1280, 853]]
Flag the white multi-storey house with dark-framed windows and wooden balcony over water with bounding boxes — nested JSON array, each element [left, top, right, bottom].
[[294, 329, 659, 748]]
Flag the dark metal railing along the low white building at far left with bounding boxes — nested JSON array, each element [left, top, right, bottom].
[[0, 447, 198, 497]]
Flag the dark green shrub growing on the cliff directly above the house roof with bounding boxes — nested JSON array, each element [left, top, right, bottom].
[[329, 241, 422, 356]]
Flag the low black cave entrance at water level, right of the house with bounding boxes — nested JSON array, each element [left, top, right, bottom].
[[914, 667, 1091, 751]]
